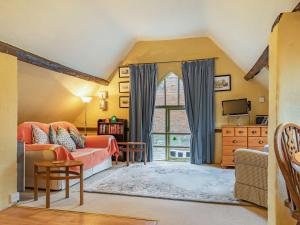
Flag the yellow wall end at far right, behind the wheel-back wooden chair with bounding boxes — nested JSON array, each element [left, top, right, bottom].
[[268, 13, 300, 225]]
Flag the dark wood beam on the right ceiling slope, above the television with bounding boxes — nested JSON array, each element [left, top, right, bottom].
[[244, 2, 300, 80]]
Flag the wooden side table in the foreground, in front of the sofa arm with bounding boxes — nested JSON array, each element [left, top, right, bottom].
[[34, 160, 83, 208]]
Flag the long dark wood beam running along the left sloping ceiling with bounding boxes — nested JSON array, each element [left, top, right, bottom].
[[0, 41, 109, 85]]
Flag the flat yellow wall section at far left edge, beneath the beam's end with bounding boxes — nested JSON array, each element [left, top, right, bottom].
[[0, 53, 17, 210]]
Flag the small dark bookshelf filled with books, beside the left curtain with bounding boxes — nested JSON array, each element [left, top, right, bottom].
[[97, 119, 128, 142]]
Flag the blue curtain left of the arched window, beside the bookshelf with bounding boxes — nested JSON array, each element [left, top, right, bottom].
[[129, 64, 157, 161]]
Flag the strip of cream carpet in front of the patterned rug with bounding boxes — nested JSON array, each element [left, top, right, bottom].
[[20, 163, 267, 225]]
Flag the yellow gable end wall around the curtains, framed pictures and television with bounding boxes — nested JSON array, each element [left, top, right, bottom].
[[75, 37, 268, 162]]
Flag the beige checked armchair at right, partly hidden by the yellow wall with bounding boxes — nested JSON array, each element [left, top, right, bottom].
[[234, 149, 268, 207]]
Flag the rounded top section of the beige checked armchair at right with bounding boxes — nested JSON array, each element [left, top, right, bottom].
[[234, 149, 269, 168]]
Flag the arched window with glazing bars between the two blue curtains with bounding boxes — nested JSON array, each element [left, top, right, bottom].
[[152, 73, 191, 161]]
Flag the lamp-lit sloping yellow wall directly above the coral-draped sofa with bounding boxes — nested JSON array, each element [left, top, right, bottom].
[[18, 61, 100, 123]]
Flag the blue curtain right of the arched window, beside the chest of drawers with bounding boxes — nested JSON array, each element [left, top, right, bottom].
[[182, 59, 215, 165]]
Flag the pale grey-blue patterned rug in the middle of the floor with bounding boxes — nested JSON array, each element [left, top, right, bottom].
[[84, 162, 248, 205]]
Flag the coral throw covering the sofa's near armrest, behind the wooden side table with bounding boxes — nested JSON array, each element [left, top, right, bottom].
[[25, 144, 74, 160]]
